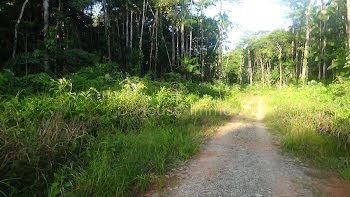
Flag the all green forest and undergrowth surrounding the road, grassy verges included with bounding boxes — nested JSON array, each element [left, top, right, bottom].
[[0, 0, 350, 196]]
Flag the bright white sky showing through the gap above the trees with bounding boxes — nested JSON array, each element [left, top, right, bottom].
[[205, 0, 291, 49]]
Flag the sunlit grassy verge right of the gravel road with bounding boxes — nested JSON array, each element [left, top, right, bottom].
[[266, 83, 350, 180]]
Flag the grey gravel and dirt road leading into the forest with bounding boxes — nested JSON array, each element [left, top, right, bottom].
[[152, 98, 349, 197]]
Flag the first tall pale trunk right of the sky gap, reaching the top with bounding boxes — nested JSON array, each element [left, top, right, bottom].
[[301, 0, 311, 84]]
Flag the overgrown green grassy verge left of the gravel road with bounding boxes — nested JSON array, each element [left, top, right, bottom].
[[0, 70, 240, 196]]
